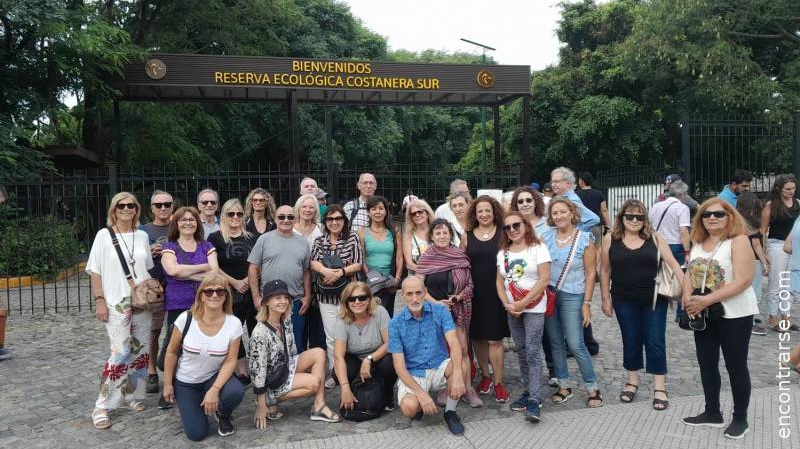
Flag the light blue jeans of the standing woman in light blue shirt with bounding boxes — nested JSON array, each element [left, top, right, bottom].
[[544, 292, 597, 391]]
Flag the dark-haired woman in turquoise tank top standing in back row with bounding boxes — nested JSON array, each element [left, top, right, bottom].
[[358, 195, 403, 317]]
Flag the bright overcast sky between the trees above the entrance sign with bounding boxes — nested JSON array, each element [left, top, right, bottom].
[[342, 0, 560, 70]]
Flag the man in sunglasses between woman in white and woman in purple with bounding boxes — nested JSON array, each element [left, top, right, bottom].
[[139, 190, 174, 393]]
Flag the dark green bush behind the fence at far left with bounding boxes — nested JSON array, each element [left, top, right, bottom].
[[0, 217, 80, 279]]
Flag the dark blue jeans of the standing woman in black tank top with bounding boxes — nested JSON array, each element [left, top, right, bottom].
[[612, 297, 667, 374]]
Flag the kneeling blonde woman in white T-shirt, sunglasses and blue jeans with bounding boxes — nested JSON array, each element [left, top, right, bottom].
[[162, 272, 244, 441]]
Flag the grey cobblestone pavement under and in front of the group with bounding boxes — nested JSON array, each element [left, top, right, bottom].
[[0, 288, 800, 448]]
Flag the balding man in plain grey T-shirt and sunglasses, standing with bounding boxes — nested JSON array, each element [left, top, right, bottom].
[[247, 205, 313, 353]]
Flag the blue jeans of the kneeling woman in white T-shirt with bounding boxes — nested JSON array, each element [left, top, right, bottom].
[[175, 374, 244, 441]]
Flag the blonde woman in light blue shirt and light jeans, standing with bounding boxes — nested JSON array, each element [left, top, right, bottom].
[[542, 196, 603, 408]]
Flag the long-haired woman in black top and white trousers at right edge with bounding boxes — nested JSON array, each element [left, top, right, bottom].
[[761, 175, 800, 332]]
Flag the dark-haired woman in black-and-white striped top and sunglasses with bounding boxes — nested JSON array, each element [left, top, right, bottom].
[[311, 204, 364, 388]]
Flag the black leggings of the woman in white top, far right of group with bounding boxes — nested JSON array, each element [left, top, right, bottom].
[[694, 315, 753, 417]]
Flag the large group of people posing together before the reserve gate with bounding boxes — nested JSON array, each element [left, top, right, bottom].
[[86, 167, 800, 441]]
